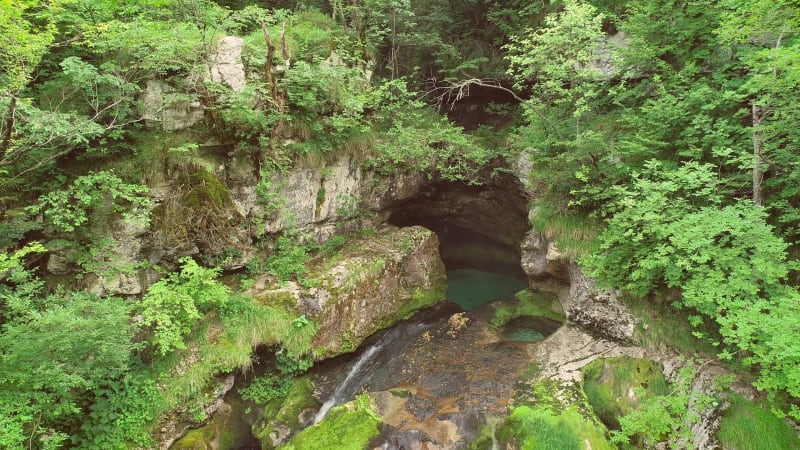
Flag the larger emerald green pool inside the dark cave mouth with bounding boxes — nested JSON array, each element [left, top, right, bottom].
[[447, 269, 528, 311]]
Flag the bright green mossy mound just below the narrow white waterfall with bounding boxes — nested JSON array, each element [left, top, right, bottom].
[[278, 395, 381, 450]]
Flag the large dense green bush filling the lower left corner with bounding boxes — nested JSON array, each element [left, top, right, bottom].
[[0, 292, 135, 448]]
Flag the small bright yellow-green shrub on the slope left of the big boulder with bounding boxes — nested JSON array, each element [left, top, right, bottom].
[[141, 258, 230, 355]]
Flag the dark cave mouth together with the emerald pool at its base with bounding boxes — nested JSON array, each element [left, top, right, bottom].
[[389, 174, 528, 310]]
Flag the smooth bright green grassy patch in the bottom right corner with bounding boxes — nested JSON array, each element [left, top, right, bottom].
[[717, 393, 800, 450]]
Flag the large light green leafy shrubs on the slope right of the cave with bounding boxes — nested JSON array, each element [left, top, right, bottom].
[[585, 163, 800, 412]]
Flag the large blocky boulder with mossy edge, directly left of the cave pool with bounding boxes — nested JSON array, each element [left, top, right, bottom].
[[252, 227, 447, 359]]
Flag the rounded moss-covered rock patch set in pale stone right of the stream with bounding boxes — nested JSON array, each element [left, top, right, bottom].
[[582, 357, 670, 429]]
